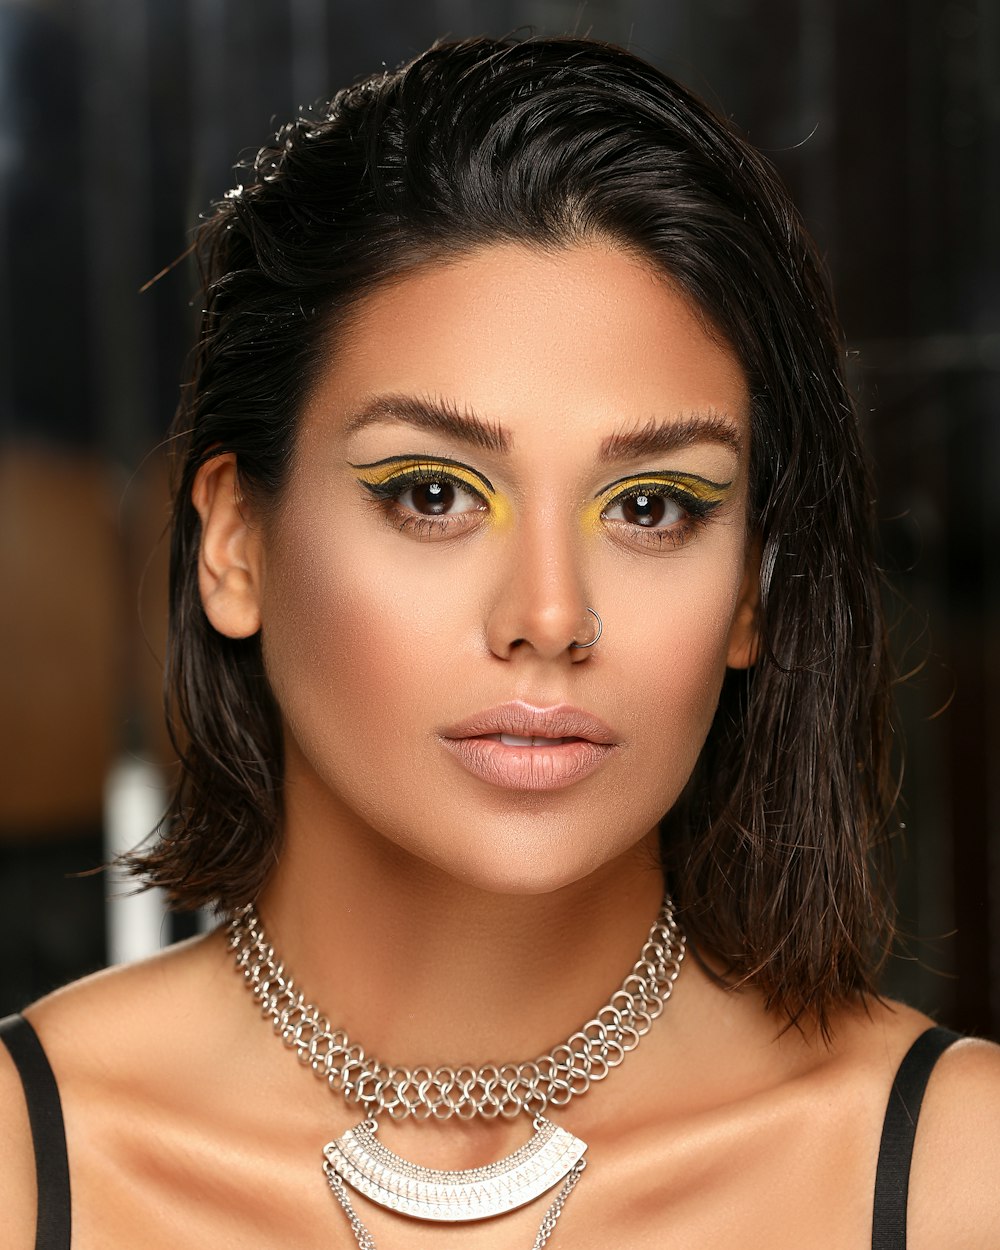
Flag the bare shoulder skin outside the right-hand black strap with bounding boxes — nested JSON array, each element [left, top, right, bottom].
[[909, 1038, 1000, 1250]]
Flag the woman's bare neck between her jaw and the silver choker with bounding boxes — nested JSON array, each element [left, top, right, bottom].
[[259, 780, 663, 1066]]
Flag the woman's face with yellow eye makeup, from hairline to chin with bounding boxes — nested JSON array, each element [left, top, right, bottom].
[[236, 243, 756, 893]]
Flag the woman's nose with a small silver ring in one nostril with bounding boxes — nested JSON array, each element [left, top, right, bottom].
[[486, 518, 596, 664]]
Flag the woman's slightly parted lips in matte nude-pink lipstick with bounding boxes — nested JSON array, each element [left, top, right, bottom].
[[441, 703, 616, 790]]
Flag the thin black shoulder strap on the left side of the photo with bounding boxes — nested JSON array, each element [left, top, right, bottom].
[[0, 1015, 70, 1250]]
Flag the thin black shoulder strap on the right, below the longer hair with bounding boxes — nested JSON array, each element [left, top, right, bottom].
[[871, 1029, 959, 1250]]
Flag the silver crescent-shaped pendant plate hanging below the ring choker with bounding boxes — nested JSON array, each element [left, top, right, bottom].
[[323, 1116, 586, 1221]]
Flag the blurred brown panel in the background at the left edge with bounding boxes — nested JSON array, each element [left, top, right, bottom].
[[0, 448, 125, 836]]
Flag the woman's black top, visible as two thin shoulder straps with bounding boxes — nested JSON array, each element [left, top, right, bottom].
[[0, 1015, 959, 1250]]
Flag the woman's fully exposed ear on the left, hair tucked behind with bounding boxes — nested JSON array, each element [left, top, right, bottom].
[[191, 453, 263, 638]]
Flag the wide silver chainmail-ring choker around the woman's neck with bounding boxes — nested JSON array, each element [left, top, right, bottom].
[[229, 896, 685, 1120]]
